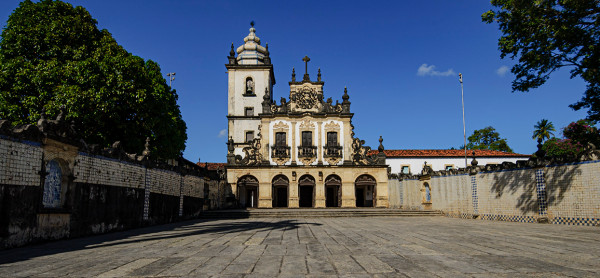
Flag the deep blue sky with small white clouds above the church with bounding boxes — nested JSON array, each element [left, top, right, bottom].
[[0, 0, 586, 162]]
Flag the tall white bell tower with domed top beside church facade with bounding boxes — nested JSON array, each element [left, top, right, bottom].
[[225, 21, 275, 156]]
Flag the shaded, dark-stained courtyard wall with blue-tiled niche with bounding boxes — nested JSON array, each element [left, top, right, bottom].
[[0, 135, 224, 249]]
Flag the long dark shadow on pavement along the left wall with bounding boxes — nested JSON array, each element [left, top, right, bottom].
[[0, 219, 322, 268]]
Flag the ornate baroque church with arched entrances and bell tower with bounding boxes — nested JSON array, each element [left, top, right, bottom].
[[225, 24, 389, 208]]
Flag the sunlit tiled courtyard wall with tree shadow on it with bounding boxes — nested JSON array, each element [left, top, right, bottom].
[[389, 160, 600, 226]]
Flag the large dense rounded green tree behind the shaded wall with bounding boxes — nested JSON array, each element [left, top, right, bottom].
[[0, 0, 187, 158]]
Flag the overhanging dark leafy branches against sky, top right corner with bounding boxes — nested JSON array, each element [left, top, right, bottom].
[[482, 0, 600, 120]]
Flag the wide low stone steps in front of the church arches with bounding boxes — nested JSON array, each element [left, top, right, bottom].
[[200, 208, 443, 218]]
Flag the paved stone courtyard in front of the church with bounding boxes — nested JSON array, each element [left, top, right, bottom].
[[0, 217, 600, 277]]
